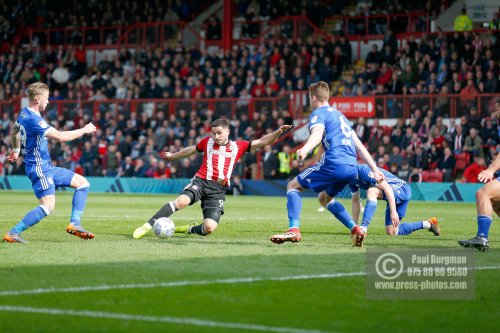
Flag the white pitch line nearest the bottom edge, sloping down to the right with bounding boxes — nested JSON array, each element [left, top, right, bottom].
[[0, 305, 332, 333]]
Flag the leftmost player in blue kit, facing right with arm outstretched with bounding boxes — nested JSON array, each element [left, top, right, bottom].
[[3, 82, 96, 243]]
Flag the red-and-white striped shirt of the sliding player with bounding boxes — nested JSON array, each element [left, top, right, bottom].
[[196, 137, 250, 186]]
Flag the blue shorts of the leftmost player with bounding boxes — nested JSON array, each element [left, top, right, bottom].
[[26, 165, 75, 199]]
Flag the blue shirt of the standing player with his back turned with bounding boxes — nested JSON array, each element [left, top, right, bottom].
[[309, 105, 357, 165]]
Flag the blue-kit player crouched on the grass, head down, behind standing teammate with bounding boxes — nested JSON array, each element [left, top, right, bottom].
[[330, 164, 440, 236]]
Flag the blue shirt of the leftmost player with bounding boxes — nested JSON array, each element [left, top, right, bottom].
[[16, 107, 53, 173]]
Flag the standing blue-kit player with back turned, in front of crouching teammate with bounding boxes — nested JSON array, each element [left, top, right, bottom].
[[271, 81, 384, 246]]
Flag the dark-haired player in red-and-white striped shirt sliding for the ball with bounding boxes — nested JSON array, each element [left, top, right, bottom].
[[133, 119, 292, 239]]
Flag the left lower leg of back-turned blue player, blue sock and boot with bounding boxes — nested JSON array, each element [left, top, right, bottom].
[[271, 185, 302, 244]]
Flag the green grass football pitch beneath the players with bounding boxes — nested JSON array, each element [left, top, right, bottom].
[[0, 191, 500, 333]]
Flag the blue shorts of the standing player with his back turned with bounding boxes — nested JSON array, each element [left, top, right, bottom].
[[297, 162, 358, 198]]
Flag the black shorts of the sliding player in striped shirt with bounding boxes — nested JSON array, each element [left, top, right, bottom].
[[181, 177, 226, 215]]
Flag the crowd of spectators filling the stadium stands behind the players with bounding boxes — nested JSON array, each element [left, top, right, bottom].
[[0, 0, 500, 181]]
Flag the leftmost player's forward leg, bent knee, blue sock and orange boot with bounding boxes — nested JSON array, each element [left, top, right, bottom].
[[65, 174, 94, 239]]
